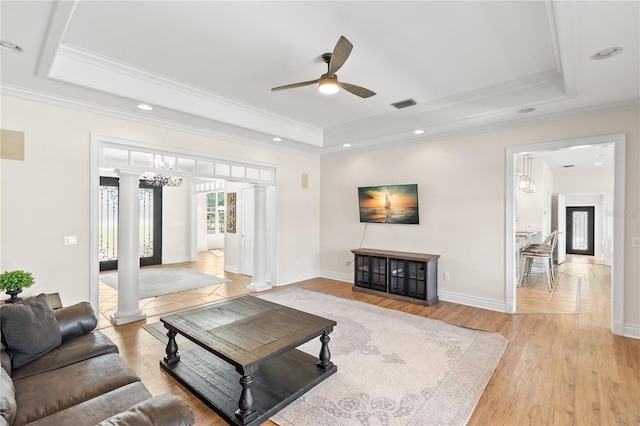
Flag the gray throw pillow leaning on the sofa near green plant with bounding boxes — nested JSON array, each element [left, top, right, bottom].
[[0, 294, 62, 368]]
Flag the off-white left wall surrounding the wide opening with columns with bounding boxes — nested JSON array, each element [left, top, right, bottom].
[[0, 95, 320, 305]]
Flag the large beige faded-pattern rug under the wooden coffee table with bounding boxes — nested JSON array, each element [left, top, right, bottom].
[[145, 288, 508, 426]]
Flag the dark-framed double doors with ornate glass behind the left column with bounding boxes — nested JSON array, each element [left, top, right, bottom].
[[98, 176, 162, 271]]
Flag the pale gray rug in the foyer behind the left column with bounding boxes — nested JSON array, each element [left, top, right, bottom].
[[100, 268, 230, 299]]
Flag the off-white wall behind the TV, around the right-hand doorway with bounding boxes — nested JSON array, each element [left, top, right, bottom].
[[320, 109, 640, 335]]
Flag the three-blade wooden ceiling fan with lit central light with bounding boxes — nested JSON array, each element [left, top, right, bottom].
[[271, 36, 376, 98]]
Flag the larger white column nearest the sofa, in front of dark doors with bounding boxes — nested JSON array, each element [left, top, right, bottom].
[[111, 170, 147, 325]]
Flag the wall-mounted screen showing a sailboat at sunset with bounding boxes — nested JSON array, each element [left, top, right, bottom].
[[358, 184, 420, 225]]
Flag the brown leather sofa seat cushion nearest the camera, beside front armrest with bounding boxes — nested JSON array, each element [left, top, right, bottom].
[[23, 382, 153, 426]]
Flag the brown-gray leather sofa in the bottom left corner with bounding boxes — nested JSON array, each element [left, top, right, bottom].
[[0, 295, 195, 426]]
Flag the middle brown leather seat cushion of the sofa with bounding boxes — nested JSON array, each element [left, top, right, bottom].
[[13, 353, 140, 426]]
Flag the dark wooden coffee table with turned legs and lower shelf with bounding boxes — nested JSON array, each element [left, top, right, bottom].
[[160, 296, 337, 425]]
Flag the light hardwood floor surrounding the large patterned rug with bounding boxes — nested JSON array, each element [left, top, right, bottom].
[[101, 254, 640, 426]]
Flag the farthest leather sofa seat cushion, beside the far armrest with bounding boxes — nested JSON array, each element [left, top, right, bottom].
[[11, 331, 118, 380]]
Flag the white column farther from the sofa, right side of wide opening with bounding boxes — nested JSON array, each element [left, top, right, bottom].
[[247, 185, 271, 291]]
